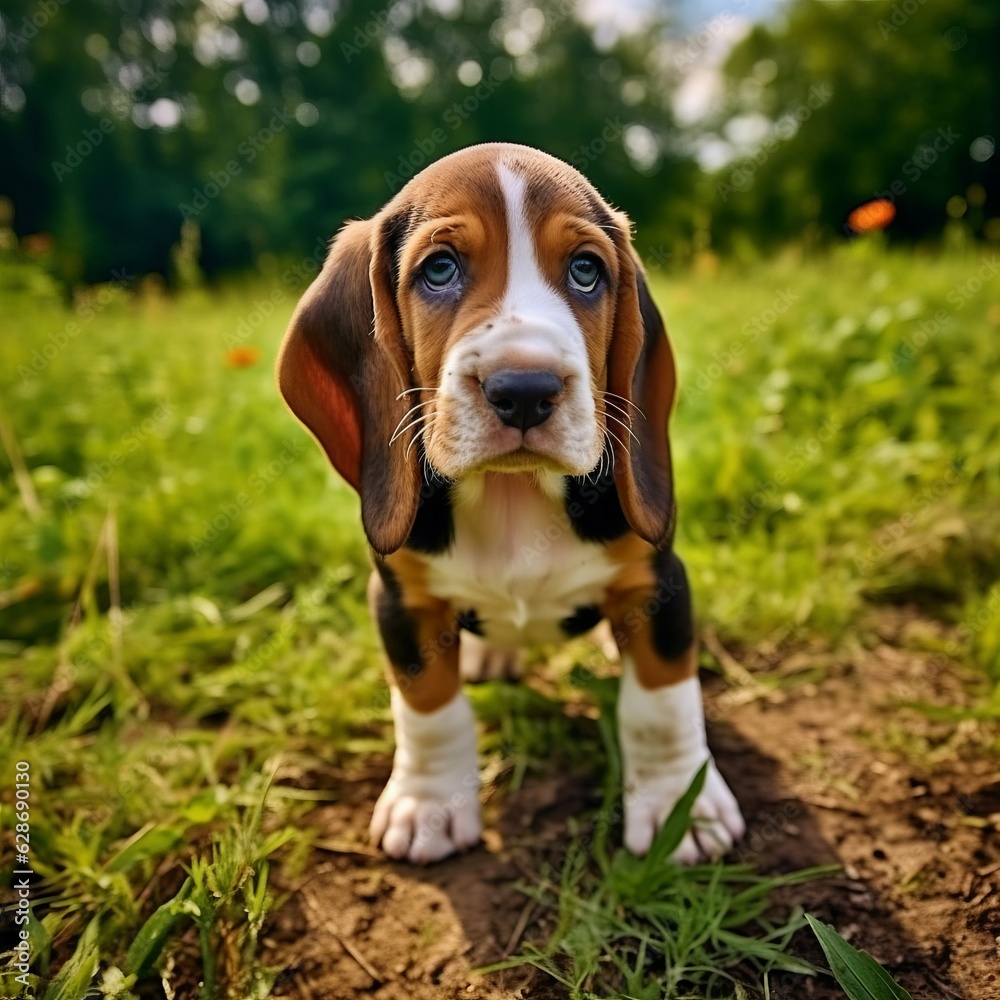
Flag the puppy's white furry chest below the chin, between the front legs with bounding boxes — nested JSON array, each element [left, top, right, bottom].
[[427, 473, 619, 646]]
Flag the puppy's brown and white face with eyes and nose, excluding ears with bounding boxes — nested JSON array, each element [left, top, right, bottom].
[[396, 159, 616, 479]]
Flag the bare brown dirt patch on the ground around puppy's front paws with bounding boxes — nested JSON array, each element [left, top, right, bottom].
[[265, 612, 1000, 1000]]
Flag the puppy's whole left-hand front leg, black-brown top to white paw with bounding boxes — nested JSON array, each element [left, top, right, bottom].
[[368, 567, 482, 863]]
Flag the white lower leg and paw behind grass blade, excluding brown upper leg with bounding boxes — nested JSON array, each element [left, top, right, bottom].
[[618, 656, 745, 864]]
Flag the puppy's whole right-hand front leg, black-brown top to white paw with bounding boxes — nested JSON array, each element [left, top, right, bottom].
[[610, 553, 744, 864]]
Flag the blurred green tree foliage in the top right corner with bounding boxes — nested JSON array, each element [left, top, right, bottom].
[[716, 0, 1000, 248]]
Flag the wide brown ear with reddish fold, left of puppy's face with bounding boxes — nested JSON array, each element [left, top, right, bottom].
[[276, 216, 420, 555]]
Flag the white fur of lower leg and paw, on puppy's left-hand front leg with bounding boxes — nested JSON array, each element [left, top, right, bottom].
[[370, 687, 482, 863]]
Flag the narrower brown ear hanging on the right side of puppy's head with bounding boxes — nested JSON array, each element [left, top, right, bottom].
[[608, 224, 677, 548]]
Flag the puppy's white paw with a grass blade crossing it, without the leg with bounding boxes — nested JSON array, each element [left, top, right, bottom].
[[625, 761, 746, 865]]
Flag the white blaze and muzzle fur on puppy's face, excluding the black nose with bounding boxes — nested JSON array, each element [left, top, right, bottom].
[[428, 163, 604, 478]]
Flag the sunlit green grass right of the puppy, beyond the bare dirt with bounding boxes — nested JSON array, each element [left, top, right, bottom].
[[660, 240, 1000, 640]]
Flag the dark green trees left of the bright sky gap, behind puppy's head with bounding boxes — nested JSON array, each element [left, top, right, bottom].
[[0, 0, 695, 286]]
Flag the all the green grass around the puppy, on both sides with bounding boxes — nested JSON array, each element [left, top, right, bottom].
[[0, 240, 1000, 1000]]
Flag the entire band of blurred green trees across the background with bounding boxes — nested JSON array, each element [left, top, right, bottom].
[[0, 0, 1000, 281]]
